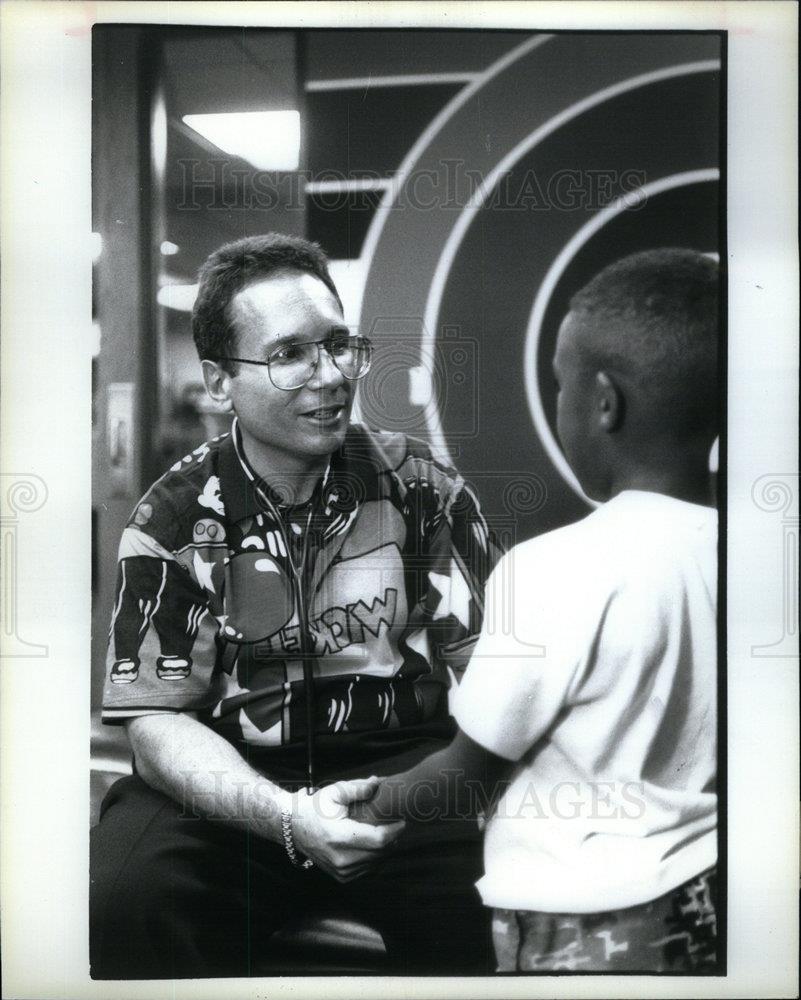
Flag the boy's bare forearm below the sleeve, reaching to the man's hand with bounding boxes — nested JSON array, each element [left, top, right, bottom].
[[349, 729, 512, 823]]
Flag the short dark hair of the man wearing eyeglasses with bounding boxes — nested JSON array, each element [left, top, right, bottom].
[[192, 233, 342, 368]]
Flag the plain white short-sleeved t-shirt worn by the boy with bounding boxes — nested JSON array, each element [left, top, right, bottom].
[[454, 491, 717, 913]]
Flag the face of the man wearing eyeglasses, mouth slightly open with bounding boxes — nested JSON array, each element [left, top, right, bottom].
[[220, 271, 355, 471]]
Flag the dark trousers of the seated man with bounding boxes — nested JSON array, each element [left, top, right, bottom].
[[90, 775, 493, 979]]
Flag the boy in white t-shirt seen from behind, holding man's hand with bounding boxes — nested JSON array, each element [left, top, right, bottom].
[[354, 249, 719, 973]]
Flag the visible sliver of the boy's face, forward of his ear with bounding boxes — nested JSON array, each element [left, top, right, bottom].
[[553, 313, 601, 499]]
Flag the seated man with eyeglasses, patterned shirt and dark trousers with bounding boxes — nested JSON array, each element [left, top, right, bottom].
[[90, 234, 497, 978]]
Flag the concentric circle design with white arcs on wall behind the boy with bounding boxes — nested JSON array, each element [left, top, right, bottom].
[[361, 34, 720, 540]]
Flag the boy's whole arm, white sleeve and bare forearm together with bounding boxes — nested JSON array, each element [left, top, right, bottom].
[[353, 544, 584, 826]]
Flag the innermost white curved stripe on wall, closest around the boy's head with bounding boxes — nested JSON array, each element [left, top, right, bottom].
[[523, 168, 720, 507]]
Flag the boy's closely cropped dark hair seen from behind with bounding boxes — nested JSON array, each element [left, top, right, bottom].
[[570, 247, 720, 434]]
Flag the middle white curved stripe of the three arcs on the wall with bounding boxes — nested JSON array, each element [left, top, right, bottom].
[[418, 60, 720, 470]]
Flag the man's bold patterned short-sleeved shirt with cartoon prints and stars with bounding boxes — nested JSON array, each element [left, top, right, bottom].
[[103, 422, 498, 776]]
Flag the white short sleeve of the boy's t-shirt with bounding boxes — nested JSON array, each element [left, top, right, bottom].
[[453, 543, 582, 760]]
